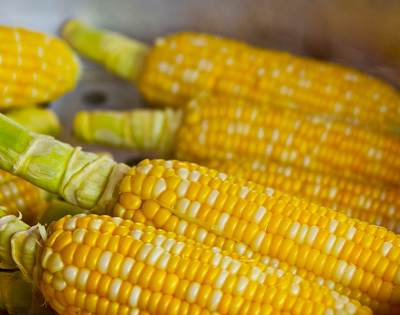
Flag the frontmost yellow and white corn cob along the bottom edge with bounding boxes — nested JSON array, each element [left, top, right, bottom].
[[0, 210, 372, 315]]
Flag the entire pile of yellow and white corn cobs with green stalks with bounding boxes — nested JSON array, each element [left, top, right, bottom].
[[0, 17, 400, 315]]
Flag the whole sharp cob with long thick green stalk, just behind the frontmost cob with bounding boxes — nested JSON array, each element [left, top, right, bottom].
[[0, 115, 400, 314]]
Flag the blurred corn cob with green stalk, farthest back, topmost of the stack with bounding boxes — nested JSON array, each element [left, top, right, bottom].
[[63, 20, 400, 130]]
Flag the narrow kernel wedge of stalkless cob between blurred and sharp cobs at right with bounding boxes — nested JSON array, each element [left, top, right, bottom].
[[202, 160, 400, 233]]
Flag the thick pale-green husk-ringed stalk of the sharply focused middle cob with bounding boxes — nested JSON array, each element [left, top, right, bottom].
[[0, 114, 129, 213]]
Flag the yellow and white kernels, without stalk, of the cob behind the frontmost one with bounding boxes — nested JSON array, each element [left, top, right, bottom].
[[114, 160, 400, 315]]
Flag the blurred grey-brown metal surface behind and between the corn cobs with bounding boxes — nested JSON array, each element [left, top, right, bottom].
[[0, 0, 400, 161]]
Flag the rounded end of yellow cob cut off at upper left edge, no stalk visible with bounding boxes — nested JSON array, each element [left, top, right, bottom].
[[0, 26, 79, 109]]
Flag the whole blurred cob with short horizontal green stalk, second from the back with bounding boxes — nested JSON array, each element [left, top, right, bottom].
[[74, 95, 400, 185]]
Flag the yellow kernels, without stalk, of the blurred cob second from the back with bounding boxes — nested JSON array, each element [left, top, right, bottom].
[[175, 96, 400, 185]]
